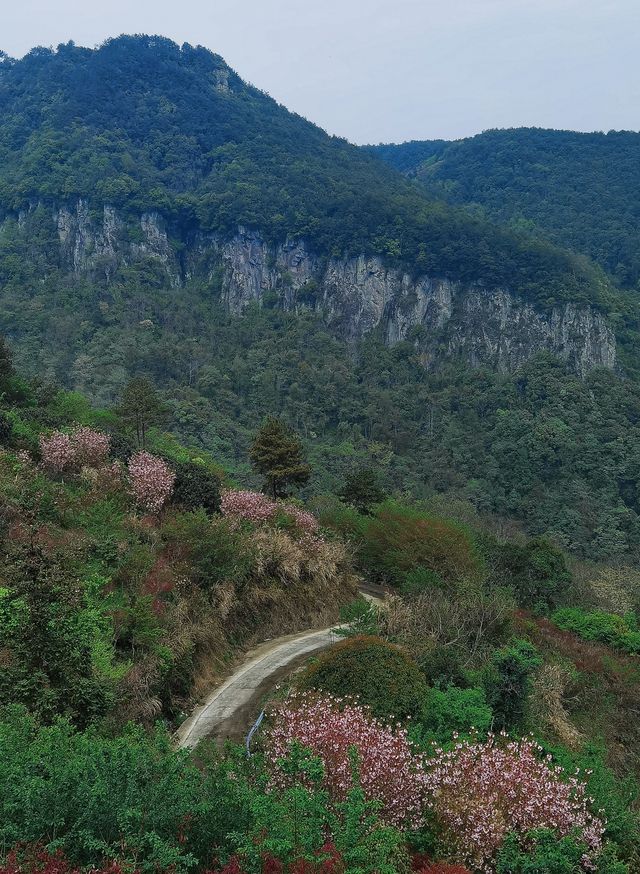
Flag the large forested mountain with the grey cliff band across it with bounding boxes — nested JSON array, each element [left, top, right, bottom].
[[0, 36, 640, 558]]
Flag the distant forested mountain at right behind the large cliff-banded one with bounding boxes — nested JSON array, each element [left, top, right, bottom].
[[367, 128, 640, 288]]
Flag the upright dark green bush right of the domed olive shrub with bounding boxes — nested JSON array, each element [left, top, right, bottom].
[[482, 640, 542, 729]]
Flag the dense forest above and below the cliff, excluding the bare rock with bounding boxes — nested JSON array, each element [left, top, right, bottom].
[[0, 37, 640, 559]]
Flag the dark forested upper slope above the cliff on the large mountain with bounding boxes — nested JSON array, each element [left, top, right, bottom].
[[0, 37, 612, 309]]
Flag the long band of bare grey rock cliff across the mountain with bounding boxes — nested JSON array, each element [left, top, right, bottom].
[[2, 200, 616, 375]]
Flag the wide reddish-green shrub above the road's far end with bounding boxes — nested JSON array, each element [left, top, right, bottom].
[[360, 502, 482, 585]]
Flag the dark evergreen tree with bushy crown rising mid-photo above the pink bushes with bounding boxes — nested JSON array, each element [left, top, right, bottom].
[[250, 416, 311, 498]]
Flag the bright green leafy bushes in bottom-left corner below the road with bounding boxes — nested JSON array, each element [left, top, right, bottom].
[[0, 708, 246, 872]]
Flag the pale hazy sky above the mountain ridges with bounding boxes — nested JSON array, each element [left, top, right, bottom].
[[0, 0, 640, 143]]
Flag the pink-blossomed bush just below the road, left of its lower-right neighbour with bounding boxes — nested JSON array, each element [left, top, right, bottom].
[[266, 693, 425, 828]]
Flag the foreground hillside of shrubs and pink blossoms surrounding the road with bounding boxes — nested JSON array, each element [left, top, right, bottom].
[[0, 358, 640, 874]]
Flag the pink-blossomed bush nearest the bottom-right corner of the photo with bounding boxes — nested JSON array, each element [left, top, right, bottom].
[[426, 735, 604, 872]]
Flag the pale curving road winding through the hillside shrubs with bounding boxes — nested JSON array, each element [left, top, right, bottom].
[[175, 585, 384, 748]]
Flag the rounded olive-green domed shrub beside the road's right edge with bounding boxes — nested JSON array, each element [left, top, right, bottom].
[[299, 636, 427, 719]]
